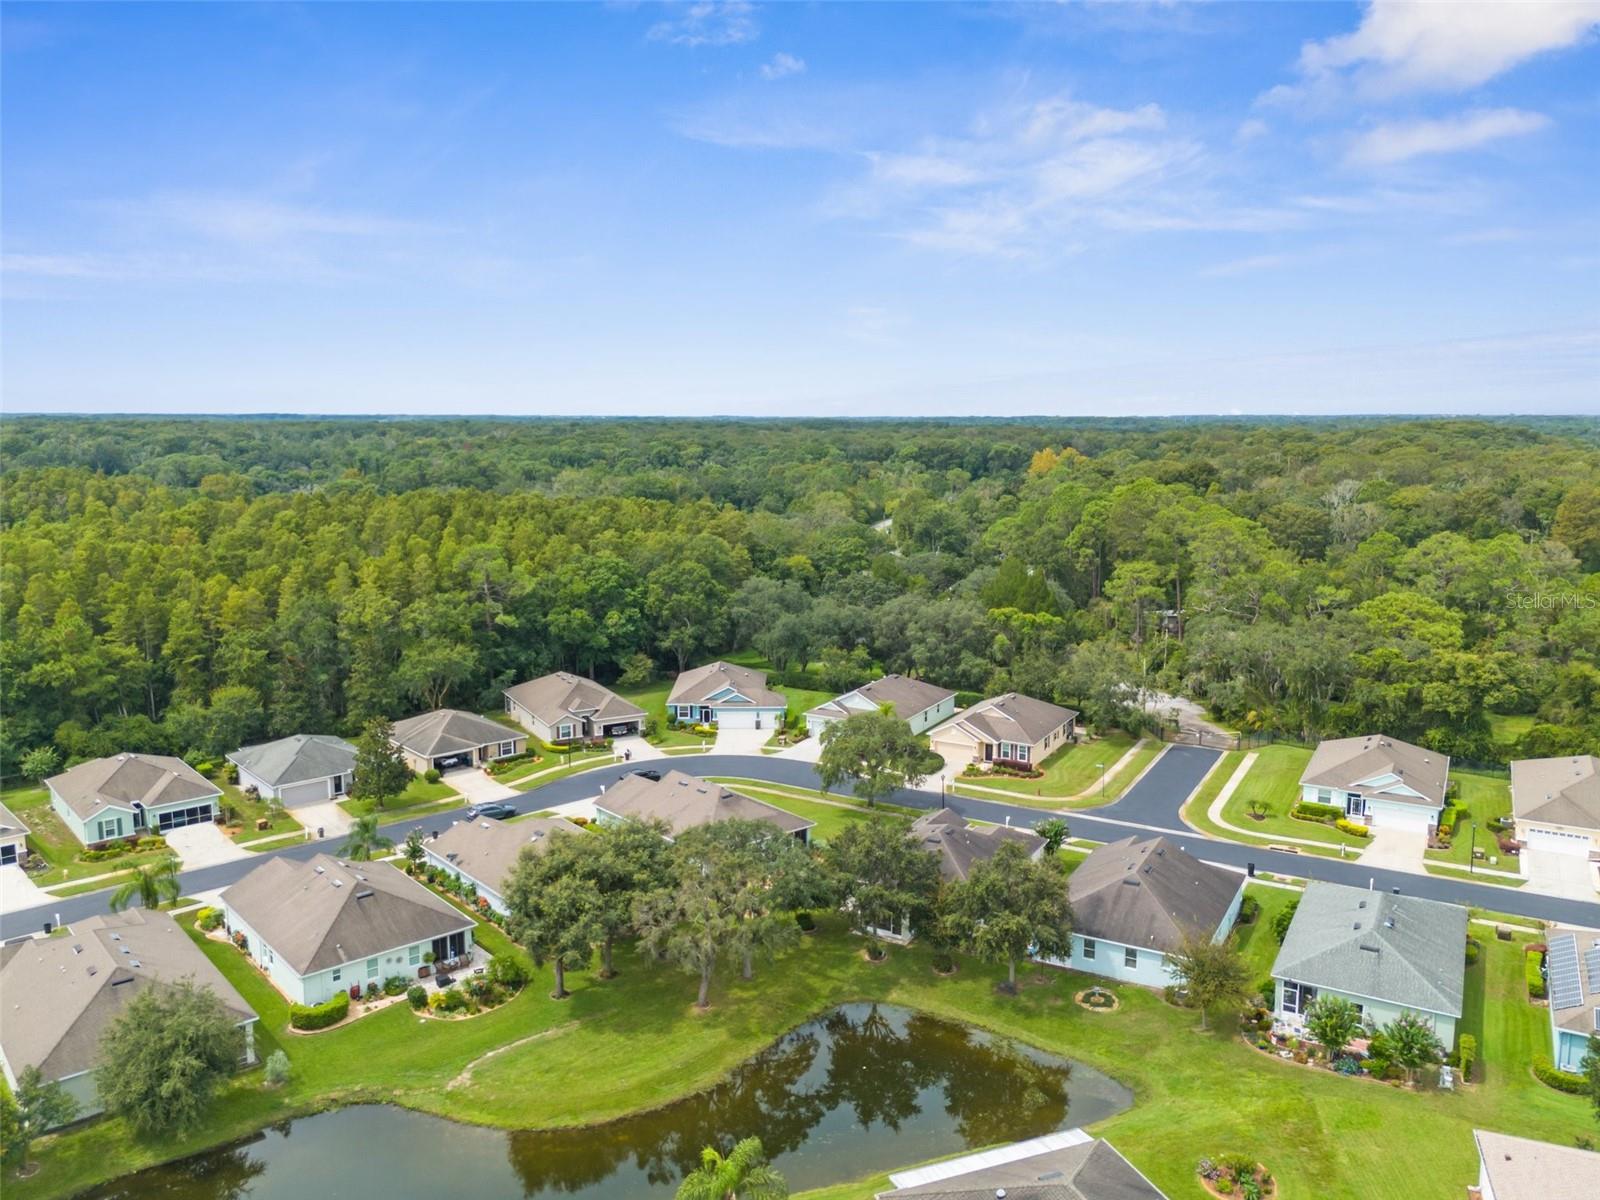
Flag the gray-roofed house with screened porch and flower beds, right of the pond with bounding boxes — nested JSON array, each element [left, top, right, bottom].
[[1272, 882, 1467, 1051]]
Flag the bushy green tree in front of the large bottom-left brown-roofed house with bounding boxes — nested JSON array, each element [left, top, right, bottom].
[[94, 979, 243, 1134]]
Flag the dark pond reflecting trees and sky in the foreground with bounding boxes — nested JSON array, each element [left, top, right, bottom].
[[90, 1005, 1133, 1200]]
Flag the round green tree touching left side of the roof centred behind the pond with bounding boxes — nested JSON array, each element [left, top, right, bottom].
[[822, 821, 939, 958]]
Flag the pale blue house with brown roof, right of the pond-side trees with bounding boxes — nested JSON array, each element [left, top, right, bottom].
[[1046, 837, 1245, 987]]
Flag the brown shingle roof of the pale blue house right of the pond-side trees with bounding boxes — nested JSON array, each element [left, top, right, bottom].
[[1067, 837, 1245, 954]]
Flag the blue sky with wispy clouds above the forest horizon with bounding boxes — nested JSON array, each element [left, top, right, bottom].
[[0, 2, 1600, 416]]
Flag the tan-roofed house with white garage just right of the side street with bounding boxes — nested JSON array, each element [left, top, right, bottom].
[[1301, 733, 1450, 834]]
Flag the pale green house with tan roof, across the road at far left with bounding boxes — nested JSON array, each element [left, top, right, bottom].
[[45, 754, 222, 846]]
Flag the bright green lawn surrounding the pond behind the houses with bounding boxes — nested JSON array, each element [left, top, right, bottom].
[[6, 886, 1594, 1200]]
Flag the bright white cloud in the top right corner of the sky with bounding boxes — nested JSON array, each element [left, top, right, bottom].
[[1270, 0, 1600, 98]]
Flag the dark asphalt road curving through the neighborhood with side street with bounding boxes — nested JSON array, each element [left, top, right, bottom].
[[0, 746, 1600, 939]]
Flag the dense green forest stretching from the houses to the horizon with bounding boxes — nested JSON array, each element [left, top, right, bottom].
[[0, 418, 1600, 774]]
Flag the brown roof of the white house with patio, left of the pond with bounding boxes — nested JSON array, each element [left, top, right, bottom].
[[222, 854, 475, 974]]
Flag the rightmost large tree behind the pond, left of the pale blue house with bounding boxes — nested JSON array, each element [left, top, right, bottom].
[[941, 838, 1072, 992]]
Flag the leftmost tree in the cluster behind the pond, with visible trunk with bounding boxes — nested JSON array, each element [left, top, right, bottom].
[[504, 857, 603, 1000]]
